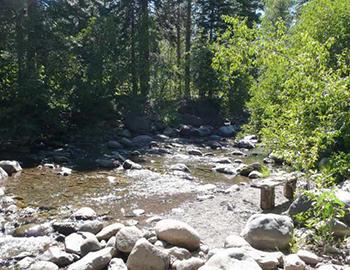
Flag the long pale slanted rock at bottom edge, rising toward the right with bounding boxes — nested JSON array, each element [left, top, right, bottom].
[[67, 248, 114, 270]]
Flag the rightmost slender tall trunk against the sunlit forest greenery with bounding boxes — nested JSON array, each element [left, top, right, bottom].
[[185, 0, 192, 100]]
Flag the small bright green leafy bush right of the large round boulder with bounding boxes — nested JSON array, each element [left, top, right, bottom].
[[296, 190, 345, 246]]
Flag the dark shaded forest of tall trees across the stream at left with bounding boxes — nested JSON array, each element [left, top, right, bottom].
[[0, 0, 261, 139]]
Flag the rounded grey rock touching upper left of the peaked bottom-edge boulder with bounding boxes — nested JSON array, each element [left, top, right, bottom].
[[115, 226, 143, 253]]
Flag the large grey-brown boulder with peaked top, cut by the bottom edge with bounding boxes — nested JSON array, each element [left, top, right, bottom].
[[126, 238, 170, 270]]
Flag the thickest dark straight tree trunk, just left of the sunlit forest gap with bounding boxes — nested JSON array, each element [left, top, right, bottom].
[[139, 0, 150, 99]]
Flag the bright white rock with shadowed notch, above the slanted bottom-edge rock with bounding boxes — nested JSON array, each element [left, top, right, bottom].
[[64, 232, 99, 255]]
